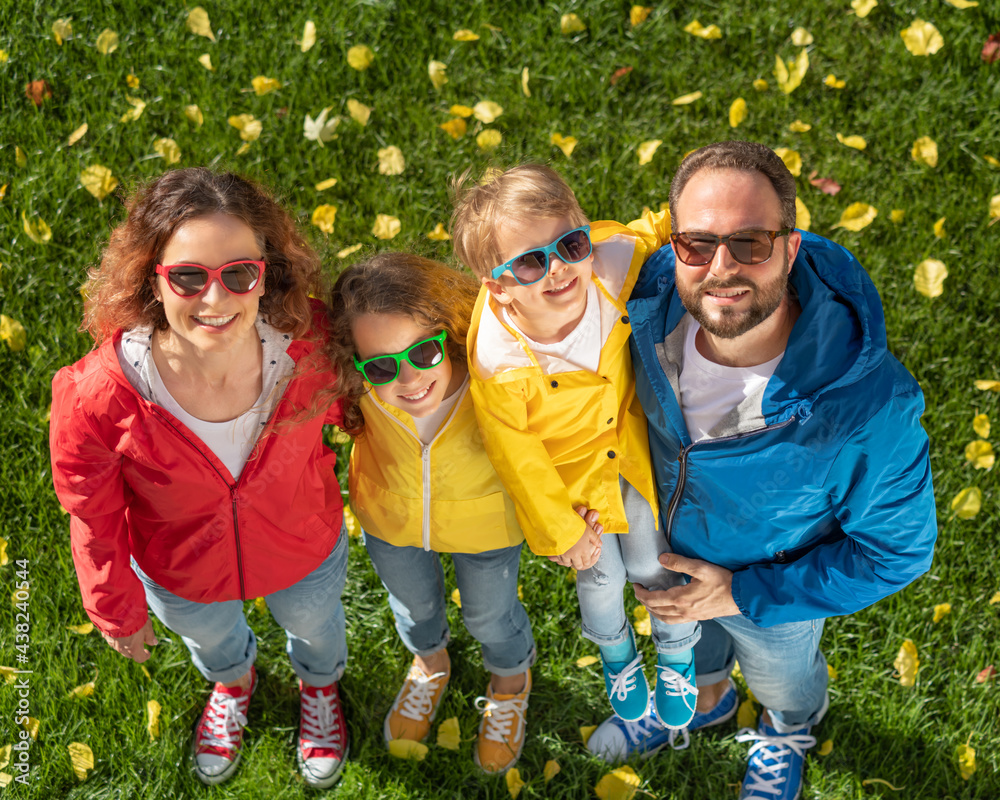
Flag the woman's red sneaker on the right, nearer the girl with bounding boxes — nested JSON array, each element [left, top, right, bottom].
[[295, 681, 347, 789]]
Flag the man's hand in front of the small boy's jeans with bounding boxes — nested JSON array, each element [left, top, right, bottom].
[[634, 553, 740, 624]]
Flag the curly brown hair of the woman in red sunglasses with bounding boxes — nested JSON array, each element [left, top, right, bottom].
[[82, 167, 323, 345]]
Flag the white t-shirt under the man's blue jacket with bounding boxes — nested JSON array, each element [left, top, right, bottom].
[[678, 314, 784, 442]]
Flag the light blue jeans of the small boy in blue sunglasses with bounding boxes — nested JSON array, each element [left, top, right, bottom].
[[576, 478, 701, 653]]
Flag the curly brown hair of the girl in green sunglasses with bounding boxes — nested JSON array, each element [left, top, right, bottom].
[[326, 253, 479, 436]]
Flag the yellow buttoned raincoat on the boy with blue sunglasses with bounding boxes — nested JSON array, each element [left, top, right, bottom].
[[468, 211, 670, 556]]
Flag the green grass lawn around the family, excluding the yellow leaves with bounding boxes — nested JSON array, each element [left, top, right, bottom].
[[0, 0, 1000, 800]]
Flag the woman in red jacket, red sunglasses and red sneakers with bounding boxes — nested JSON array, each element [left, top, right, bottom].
[[50, 169, 347, 787]]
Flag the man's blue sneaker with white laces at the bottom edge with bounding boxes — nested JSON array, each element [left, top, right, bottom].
[[736, 722, 816, 800]]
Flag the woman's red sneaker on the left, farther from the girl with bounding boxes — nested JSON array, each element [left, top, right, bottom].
[[191, 667, 257, 786]]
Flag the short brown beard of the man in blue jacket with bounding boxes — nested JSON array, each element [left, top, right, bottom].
[[676, 253, 788, 339]]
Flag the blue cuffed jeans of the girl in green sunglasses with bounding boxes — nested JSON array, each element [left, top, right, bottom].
[[364, 533, 535, 677]]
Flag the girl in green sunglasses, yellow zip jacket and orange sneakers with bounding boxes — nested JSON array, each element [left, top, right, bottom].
[[329, 253, 535, 774]]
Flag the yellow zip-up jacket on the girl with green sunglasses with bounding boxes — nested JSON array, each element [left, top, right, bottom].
[[348, 380, 524, 553]]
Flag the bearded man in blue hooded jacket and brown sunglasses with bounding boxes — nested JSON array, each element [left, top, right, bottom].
[[591, 142, 937, 800]]
